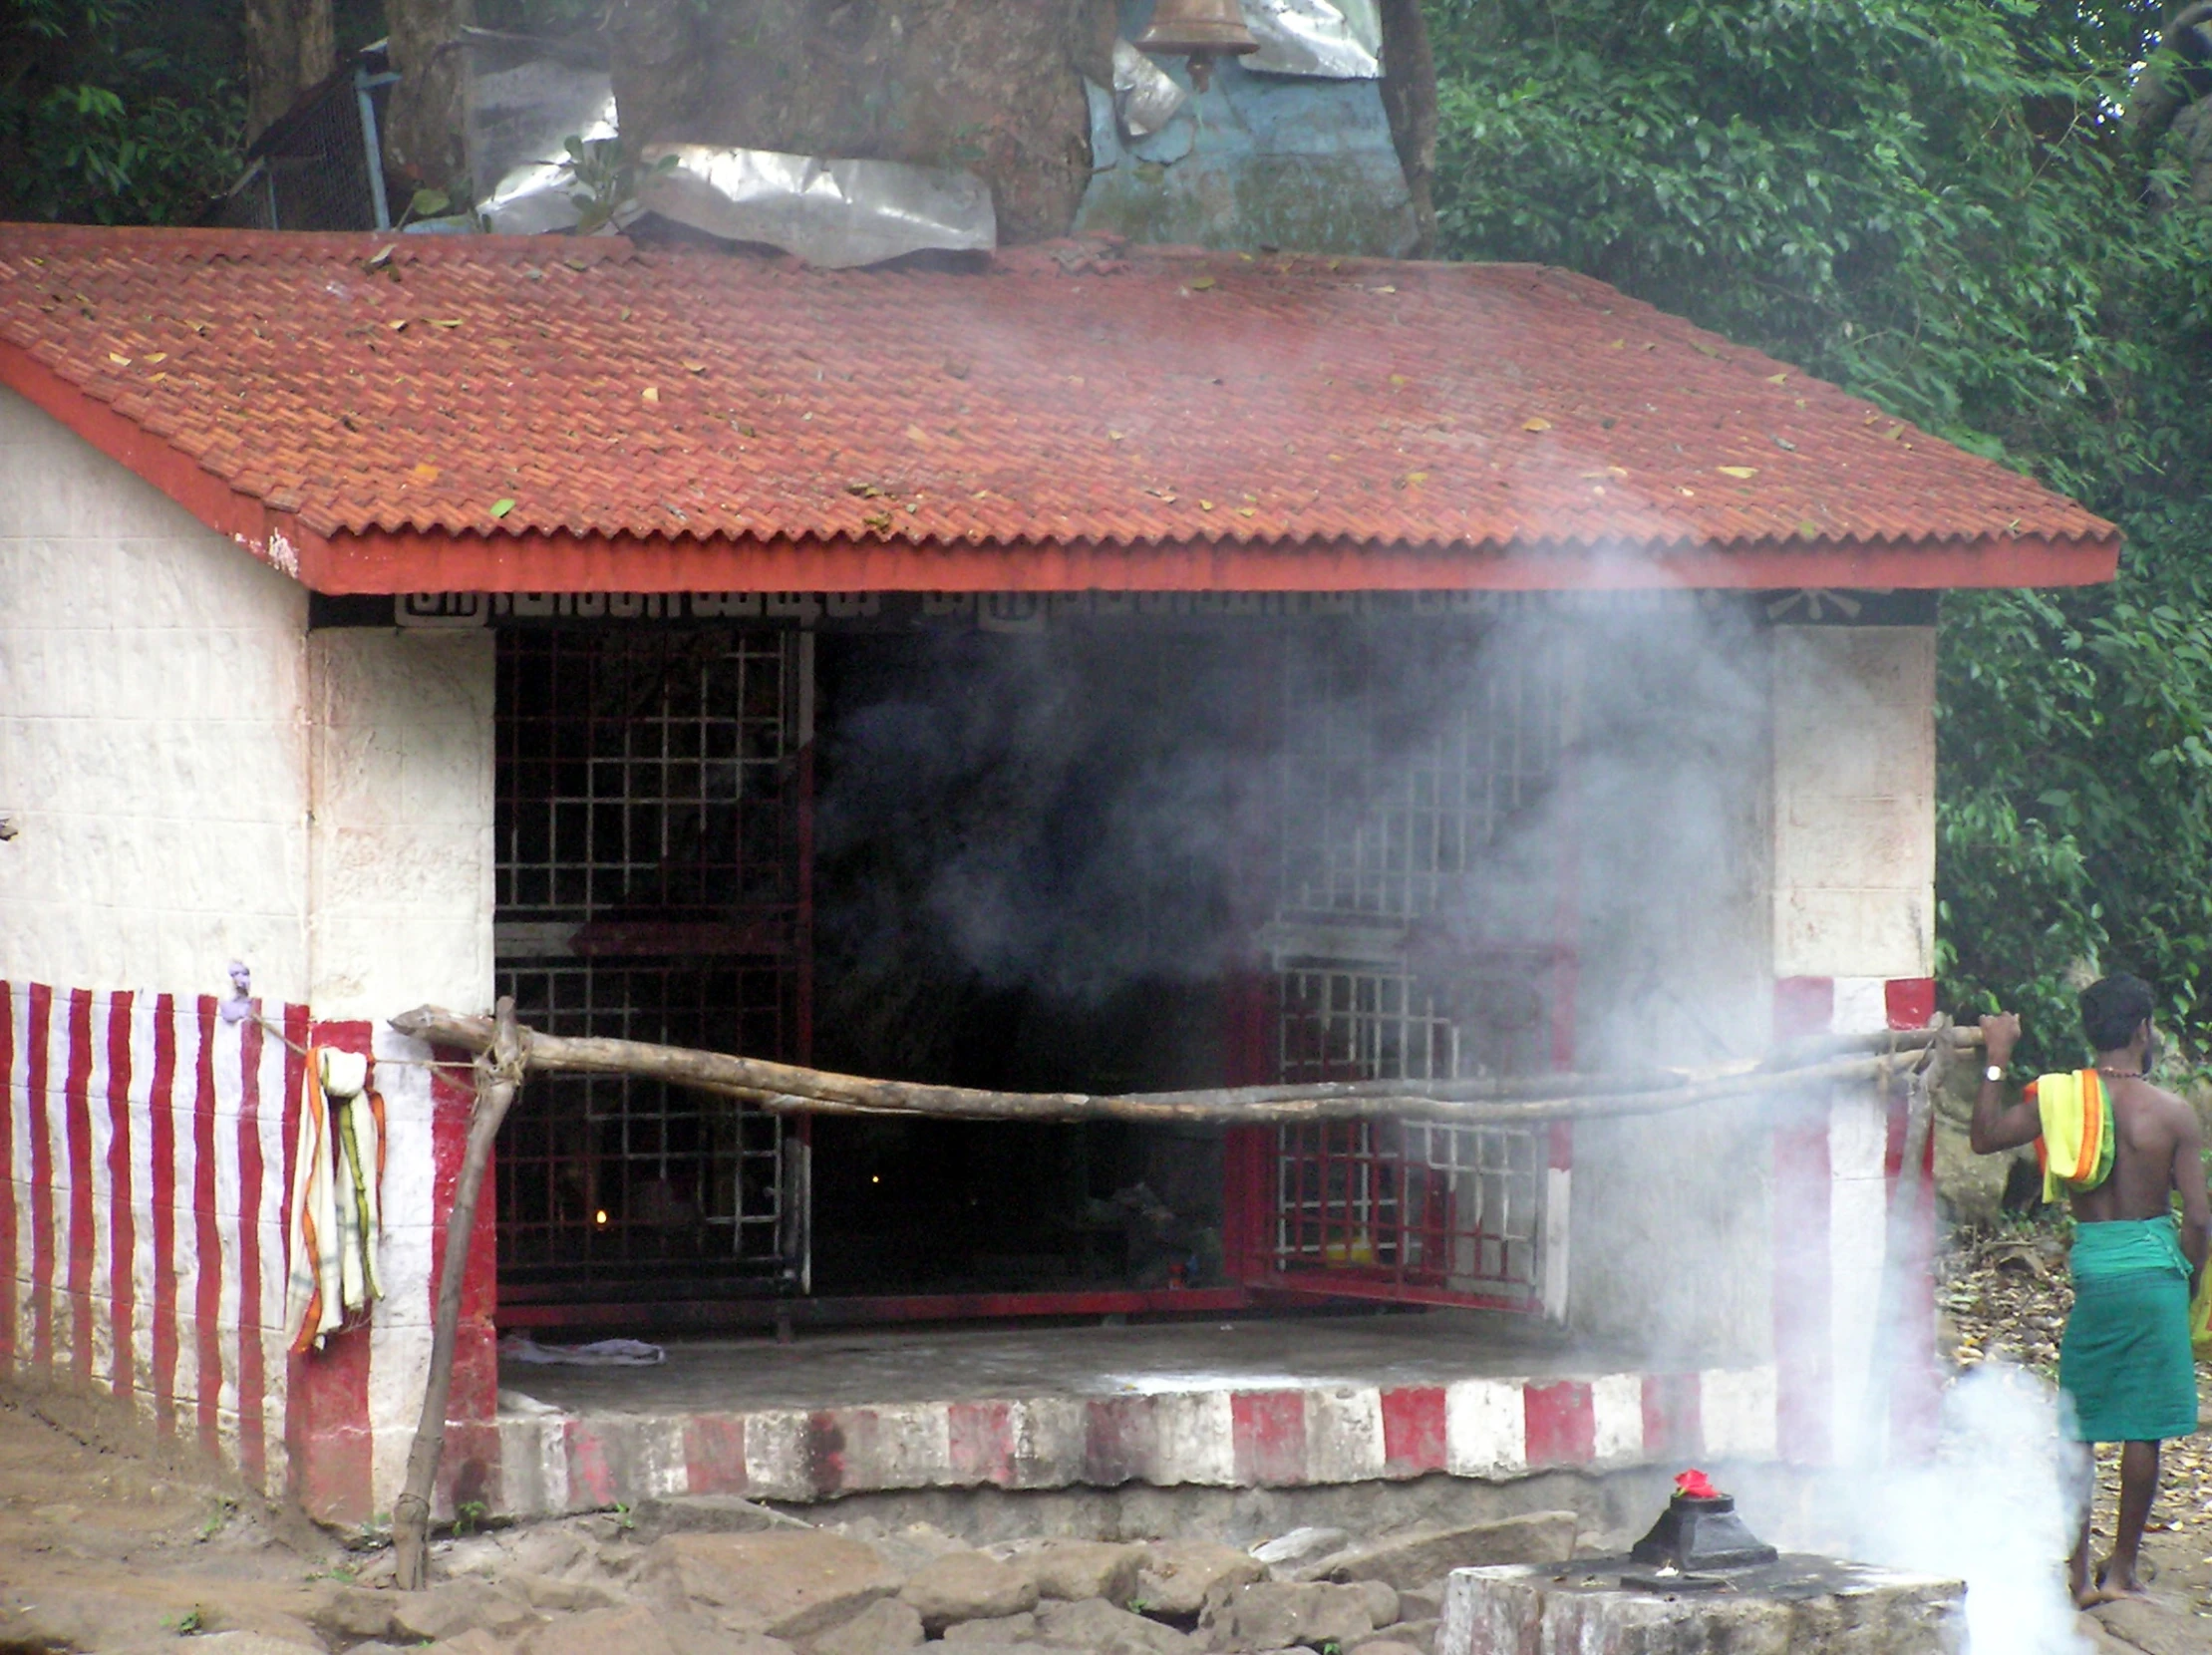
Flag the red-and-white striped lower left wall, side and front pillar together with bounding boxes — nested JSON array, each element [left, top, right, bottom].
[[0, 982, 497, 1522]]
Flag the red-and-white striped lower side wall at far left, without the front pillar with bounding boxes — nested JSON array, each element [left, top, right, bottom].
[[0, 982, 307, 1487]]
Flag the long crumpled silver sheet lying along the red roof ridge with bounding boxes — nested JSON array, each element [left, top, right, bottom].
[[637, 144, 998, 270]]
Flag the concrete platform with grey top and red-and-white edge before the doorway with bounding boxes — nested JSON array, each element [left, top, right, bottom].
[[497, 1314, 1776, 1515]]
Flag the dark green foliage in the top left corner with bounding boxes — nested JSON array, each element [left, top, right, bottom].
[[0, 0, 245, 223]]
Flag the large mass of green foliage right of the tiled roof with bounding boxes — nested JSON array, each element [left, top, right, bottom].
[[1428, 0, 2212, 1064]]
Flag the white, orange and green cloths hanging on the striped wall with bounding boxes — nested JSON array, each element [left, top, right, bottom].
[[285, 1047, 385, 1350]]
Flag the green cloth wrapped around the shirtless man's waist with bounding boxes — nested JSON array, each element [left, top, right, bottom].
[[2059, 1217, 2196, 1443]]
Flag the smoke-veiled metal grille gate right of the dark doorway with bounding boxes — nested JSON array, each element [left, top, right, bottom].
[[1265, 635, 1568, 1308]]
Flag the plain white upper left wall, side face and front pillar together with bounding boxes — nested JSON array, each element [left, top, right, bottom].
[[0, 390, 493, 1020]]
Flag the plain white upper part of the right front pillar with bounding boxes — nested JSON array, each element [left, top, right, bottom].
[[1774, 626, 1936, 982]]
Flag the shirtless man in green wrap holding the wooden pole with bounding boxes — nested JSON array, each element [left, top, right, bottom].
[[1973, 976, 2212, 1606]]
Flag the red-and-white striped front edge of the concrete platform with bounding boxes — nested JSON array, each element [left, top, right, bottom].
[[497, 1367, 1776, 1515]]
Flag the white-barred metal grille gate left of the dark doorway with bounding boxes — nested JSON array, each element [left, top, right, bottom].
[[495, 628, 805, 1301]]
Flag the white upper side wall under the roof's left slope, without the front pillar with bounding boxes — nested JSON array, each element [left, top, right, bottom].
[[0, 390, 310, 1000]]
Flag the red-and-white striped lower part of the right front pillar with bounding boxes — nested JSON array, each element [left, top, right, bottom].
[[1774, 978, 1940, 1465]]
